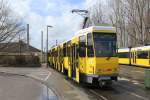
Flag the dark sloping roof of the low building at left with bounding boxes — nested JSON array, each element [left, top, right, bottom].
[[0, 41, 41, 53]]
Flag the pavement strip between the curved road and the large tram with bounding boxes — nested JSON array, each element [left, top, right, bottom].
[[46, 68, 90, 100]]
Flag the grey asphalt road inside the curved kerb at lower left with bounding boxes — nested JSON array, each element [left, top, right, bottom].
[[0, 74, 47, 100]]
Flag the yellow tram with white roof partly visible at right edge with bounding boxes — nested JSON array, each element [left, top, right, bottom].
[[118, 46, 150, 67]]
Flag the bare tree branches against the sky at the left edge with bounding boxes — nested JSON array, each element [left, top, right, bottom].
[[0, 0, 25, 43]]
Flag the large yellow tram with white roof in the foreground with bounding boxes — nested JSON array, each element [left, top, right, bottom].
[[49, 26, 118, 85]]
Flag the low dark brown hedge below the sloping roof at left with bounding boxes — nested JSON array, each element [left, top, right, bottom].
[[0, 54, 41, 67]]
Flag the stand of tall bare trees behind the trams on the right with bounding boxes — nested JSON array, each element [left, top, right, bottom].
[[82, 0, 150, 47]]
